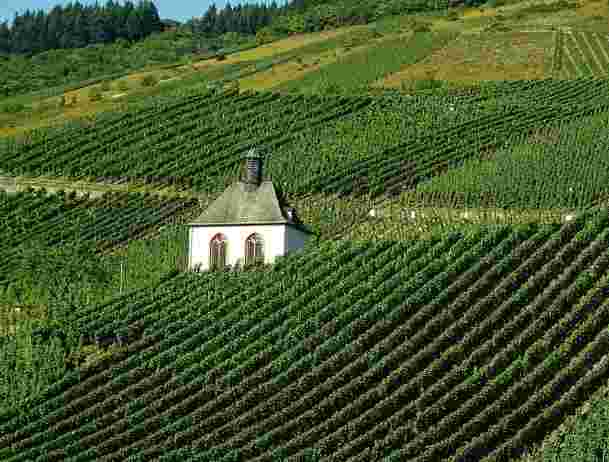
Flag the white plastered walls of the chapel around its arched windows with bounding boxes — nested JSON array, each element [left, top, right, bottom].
[[188, 225, 290, 270]]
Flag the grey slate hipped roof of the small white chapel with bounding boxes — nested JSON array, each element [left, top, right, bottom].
[[189, 181, 311, 233]]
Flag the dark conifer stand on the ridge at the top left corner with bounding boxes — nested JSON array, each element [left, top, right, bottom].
[[0, 0, 163, 54]]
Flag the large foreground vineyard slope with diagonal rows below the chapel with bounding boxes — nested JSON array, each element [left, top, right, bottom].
[[0, 209, 609, 462]]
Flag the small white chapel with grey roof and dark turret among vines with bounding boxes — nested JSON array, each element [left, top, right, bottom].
[[188, 149, 313, 271]]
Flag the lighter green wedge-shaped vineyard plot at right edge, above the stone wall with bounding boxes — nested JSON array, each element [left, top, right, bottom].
[[418, 105, 609, 209]]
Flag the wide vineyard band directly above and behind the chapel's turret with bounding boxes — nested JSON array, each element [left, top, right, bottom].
[[0, 80, 609, 205]]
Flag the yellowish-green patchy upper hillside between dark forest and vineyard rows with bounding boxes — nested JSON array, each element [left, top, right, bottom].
[[0, 0, 609, 135]]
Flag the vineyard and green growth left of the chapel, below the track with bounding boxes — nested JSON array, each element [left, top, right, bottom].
[[0, 190, 201, 416]]
